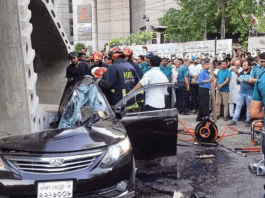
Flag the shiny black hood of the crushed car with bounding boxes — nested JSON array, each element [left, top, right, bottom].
[[0, 120, 126, 153]]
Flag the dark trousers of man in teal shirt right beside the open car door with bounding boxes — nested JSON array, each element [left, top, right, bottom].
[[178, 82, 189, 113]]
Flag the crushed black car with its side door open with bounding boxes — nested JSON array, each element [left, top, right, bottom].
[[0, 76, 178, 198]]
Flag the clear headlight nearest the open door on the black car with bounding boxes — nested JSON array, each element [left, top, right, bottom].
[[101, 136, 132, 165]]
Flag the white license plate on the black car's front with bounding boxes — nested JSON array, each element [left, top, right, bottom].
[[38, 181, 74, 198]]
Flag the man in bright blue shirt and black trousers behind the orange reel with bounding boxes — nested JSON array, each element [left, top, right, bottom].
[[196, 60, 213, 121]]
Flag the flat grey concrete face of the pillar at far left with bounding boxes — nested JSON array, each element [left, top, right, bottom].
[[0, 0, 31, 134]]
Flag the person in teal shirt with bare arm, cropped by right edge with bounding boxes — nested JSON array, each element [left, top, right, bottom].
[[249, 71, 265, 129]]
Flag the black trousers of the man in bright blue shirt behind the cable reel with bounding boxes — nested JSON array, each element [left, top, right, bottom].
[[198, 87, 210, 118]]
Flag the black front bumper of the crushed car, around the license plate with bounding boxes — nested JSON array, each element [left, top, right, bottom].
[[0, 151, 136, 198]]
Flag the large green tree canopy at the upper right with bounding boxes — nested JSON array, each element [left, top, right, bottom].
[[159, 0, 265, 49]]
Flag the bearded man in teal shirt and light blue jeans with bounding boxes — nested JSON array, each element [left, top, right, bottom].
[[228, 61, 253, 127]]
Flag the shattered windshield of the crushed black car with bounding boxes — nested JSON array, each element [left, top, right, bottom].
[[58, 83, 108, 129]]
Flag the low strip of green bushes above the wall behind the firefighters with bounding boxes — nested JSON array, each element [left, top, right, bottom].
[[108, 31, 155, 46]]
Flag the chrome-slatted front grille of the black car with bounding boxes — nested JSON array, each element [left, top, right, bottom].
[[5, 151, 103, 174]]
